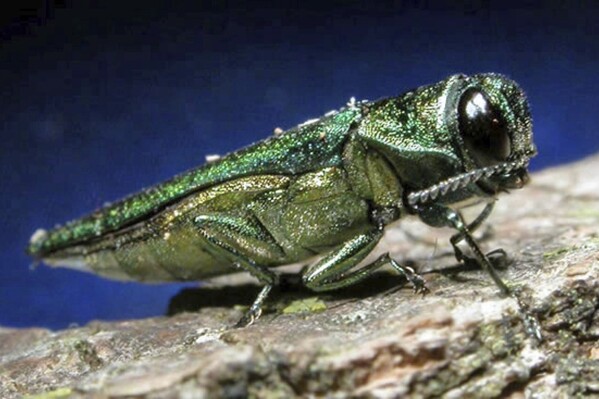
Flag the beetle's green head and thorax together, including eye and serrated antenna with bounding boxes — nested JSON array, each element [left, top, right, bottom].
[[357, 74, 536, 205]]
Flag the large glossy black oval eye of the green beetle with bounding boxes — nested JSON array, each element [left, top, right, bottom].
[[458, 88, 512, 166]]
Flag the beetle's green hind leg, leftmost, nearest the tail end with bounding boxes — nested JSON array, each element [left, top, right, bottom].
[[195, 214, 283, 327]]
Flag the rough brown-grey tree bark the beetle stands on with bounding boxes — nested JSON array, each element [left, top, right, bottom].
[[0, 156, 599, 398]]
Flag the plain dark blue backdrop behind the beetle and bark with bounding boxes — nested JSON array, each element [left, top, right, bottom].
[[0, 0, 599, 328]]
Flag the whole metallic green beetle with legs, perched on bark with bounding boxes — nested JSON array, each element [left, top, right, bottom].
[[28, 74, 538, 335]]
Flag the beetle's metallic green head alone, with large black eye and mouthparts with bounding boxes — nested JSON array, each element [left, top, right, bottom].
[[450, 74, 536, 195]]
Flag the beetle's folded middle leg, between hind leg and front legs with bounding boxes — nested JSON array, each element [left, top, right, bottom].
[[302, 229, 428, 293]]
